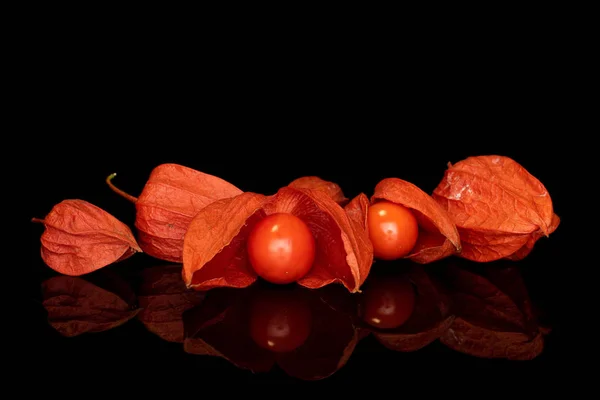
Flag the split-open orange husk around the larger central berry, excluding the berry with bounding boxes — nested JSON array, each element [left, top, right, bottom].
[[183, 187, 373, 292]]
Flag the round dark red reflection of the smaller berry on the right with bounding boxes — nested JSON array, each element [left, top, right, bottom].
[[362, 276, 415, 329]]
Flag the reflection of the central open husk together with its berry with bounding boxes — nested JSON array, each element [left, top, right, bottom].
[[184, 283, 358, 380]]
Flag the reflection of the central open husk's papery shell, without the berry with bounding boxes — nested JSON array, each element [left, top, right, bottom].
[[184, 284, 358, 380]]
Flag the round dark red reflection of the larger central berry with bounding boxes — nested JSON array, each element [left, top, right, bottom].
[[250, 289, 312, 353]]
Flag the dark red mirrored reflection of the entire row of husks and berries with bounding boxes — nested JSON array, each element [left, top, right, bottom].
[[42, 260, 548, 380]]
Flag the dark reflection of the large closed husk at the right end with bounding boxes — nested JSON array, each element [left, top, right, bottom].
[[440, 265, 549, 360]]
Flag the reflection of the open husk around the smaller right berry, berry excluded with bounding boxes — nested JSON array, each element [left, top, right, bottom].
[[363, 266, 454, 352]]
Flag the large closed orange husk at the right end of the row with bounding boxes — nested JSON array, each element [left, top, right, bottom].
[[433, 155, 560, 262]]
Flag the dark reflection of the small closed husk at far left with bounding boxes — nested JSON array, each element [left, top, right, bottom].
[[42, 270, 139, 337]]
